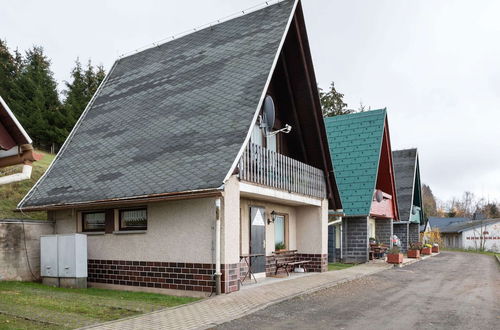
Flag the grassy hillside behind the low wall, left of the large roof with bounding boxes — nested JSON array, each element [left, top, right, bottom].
[[0, 151, 55, 220]]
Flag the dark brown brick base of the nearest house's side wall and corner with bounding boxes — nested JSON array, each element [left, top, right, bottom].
[[88, 259, 240, 293]]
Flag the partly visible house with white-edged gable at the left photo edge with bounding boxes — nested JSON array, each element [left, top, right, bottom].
[[0, 96, 41, 185]]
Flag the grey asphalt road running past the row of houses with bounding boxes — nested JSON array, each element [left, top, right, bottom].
[[218, 252, 500, 329]]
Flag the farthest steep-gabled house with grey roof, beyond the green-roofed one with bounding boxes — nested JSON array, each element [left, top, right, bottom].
[[392, 149, 425, 252]]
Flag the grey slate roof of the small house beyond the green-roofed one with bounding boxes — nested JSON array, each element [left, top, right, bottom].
[[392, 149, 418, 221]]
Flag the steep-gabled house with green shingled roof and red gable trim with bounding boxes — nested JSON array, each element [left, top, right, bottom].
[[325, 109, 399, 262]]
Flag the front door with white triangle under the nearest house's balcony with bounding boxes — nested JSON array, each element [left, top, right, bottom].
[[250, 206, 266, 274]]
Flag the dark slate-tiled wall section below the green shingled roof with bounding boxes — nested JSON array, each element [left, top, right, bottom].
[[342, 217, 368, 262]]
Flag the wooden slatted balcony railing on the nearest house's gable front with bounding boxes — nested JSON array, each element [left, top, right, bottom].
[[238, 143, 326, 198]]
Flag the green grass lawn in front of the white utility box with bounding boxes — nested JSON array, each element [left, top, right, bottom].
[[0, 281, 198, 329]]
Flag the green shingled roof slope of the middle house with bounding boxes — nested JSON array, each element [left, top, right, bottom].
[[325, 109, 386, 216]]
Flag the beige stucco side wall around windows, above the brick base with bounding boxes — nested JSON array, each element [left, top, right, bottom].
[[50, 198, 215, 263]]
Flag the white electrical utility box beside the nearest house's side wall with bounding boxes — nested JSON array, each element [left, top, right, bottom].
[[40, 234, 87, 288]]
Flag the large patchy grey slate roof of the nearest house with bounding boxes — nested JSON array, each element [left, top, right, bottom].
[[18, 0, 294, 208]]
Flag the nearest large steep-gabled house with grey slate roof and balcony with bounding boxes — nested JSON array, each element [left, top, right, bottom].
[[19, 0, 341, 295]]
